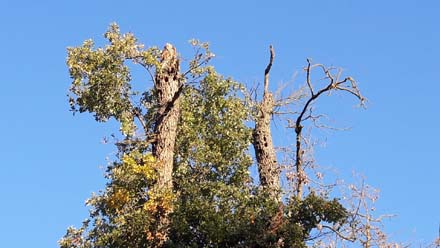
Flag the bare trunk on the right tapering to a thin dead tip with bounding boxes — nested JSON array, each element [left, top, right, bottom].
[[253, 46, 280, 201]]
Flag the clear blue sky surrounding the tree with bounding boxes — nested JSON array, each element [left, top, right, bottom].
[[0, 0, 440, 247]]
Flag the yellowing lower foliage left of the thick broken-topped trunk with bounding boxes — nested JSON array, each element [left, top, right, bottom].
[[60, 148, 166, 247]]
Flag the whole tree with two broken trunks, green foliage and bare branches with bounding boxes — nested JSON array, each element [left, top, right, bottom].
[[59, 24, 374, 247]]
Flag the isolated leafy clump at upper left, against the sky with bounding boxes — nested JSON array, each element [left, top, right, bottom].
[[67, 24, 160, 130]]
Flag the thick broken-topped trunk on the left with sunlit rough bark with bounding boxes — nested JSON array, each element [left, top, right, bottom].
[[153, 44, 180, 190]]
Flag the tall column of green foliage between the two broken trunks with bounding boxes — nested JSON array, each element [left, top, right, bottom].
[[171, 70, 253, 247]]
